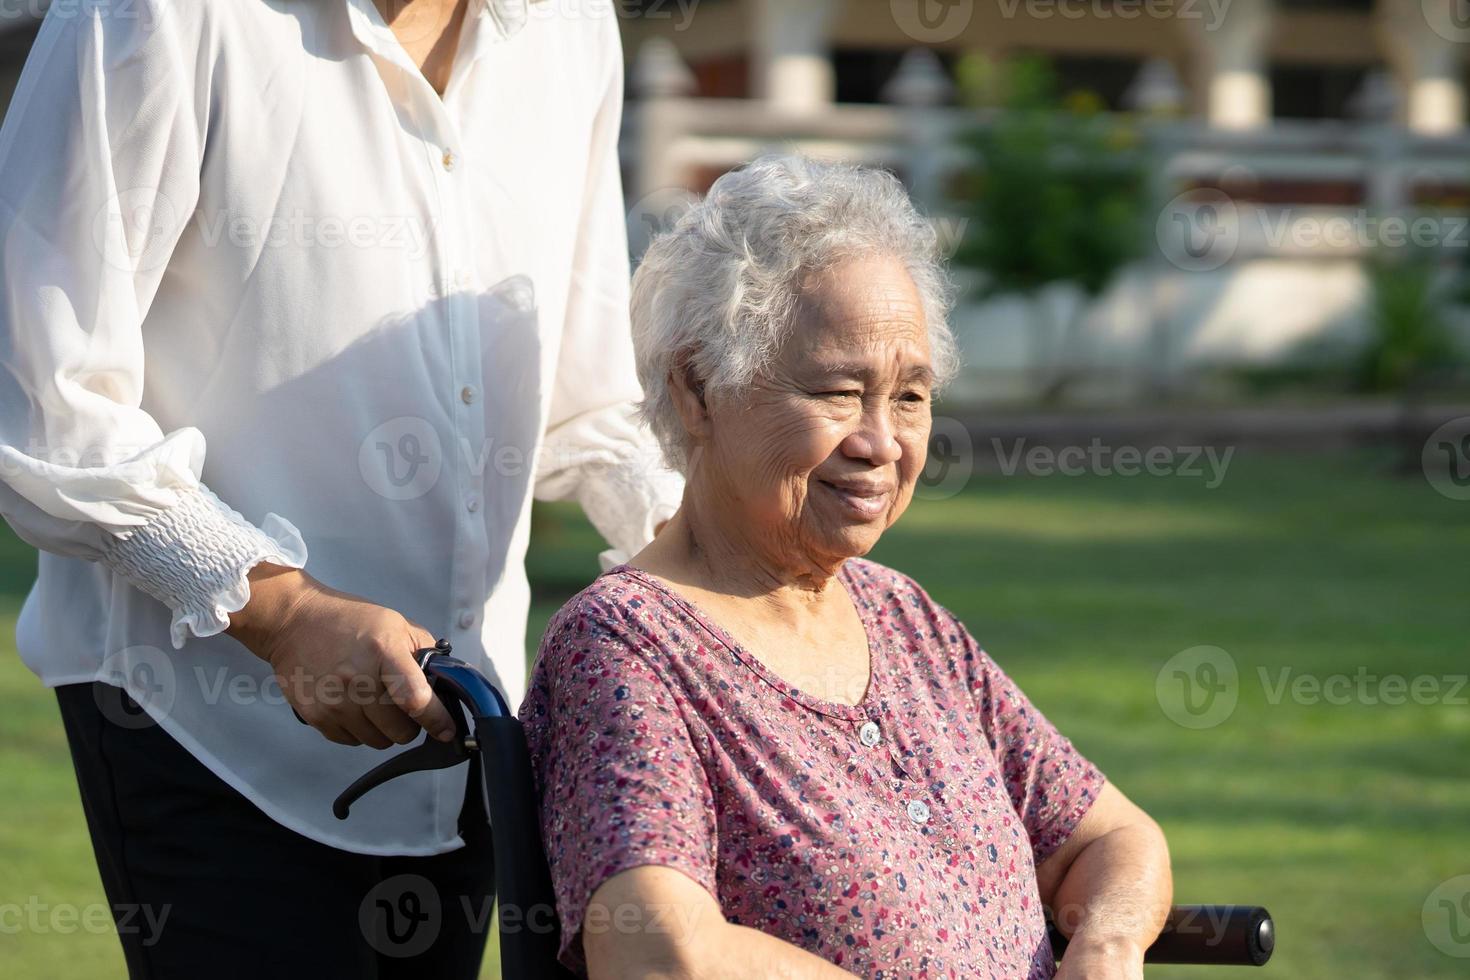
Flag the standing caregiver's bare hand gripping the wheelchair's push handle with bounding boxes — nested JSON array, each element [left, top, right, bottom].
[[225, 561, 454, 749]]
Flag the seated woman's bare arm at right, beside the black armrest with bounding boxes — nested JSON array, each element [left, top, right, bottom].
[[1036, 783, 1173, 980]]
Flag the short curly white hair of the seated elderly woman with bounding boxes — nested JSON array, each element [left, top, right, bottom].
[[632, 154, 958, 473]]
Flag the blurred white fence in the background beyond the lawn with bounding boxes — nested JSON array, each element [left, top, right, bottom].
[[623, 53, 1470, 400]]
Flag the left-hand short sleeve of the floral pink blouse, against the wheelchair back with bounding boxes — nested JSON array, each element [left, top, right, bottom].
[[520, 597, 716, 970]]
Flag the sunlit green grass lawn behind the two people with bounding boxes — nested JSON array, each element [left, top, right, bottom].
[[0, 453, 1470, 980]]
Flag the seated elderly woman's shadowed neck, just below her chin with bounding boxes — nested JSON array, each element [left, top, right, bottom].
[[634, 494, 842, 604]]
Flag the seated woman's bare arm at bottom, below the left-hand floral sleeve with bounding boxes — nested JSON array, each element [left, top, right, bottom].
[[582, 865, 853, 980]]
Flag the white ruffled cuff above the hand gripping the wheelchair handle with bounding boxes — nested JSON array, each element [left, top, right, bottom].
[[101, 483, 306, 649]]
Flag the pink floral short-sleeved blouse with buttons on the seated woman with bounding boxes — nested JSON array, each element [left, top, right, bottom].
[[520, 558, 1104, 980]]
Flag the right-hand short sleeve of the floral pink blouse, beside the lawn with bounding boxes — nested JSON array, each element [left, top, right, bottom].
[[931, 590, 1105, 865]]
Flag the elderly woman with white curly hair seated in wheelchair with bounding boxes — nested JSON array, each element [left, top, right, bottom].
[[520, 157, 1172, 980]]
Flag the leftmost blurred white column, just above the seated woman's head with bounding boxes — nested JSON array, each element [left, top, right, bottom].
[[747, 0, 836, 112]]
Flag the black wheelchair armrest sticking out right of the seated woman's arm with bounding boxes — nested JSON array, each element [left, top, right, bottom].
[[1048, 905, 1276, 967]]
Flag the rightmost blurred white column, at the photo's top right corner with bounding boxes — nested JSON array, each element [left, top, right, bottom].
[[1377, 0, 1470, 135]]
